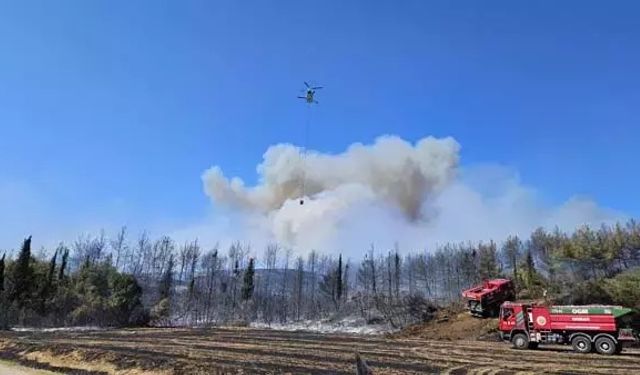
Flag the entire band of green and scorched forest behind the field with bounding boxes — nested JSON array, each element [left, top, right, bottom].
[[0, 220, 640, 329]]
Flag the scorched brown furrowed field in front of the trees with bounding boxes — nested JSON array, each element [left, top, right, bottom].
[[0, 328, 640, 374]]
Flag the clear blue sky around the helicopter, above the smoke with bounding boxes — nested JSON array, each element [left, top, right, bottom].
[[0, 1, 640, 250]]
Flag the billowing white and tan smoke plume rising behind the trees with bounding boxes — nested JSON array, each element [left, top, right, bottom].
[[202, 136, 622, 256]]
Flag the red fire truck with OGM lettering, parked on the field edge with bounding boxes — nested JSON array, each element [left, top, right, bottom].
[[499, 302, 640, 355]]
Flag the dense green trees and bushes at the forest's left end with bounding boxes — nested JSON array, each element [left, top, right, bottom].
[[0, 237, 148, 329]]
